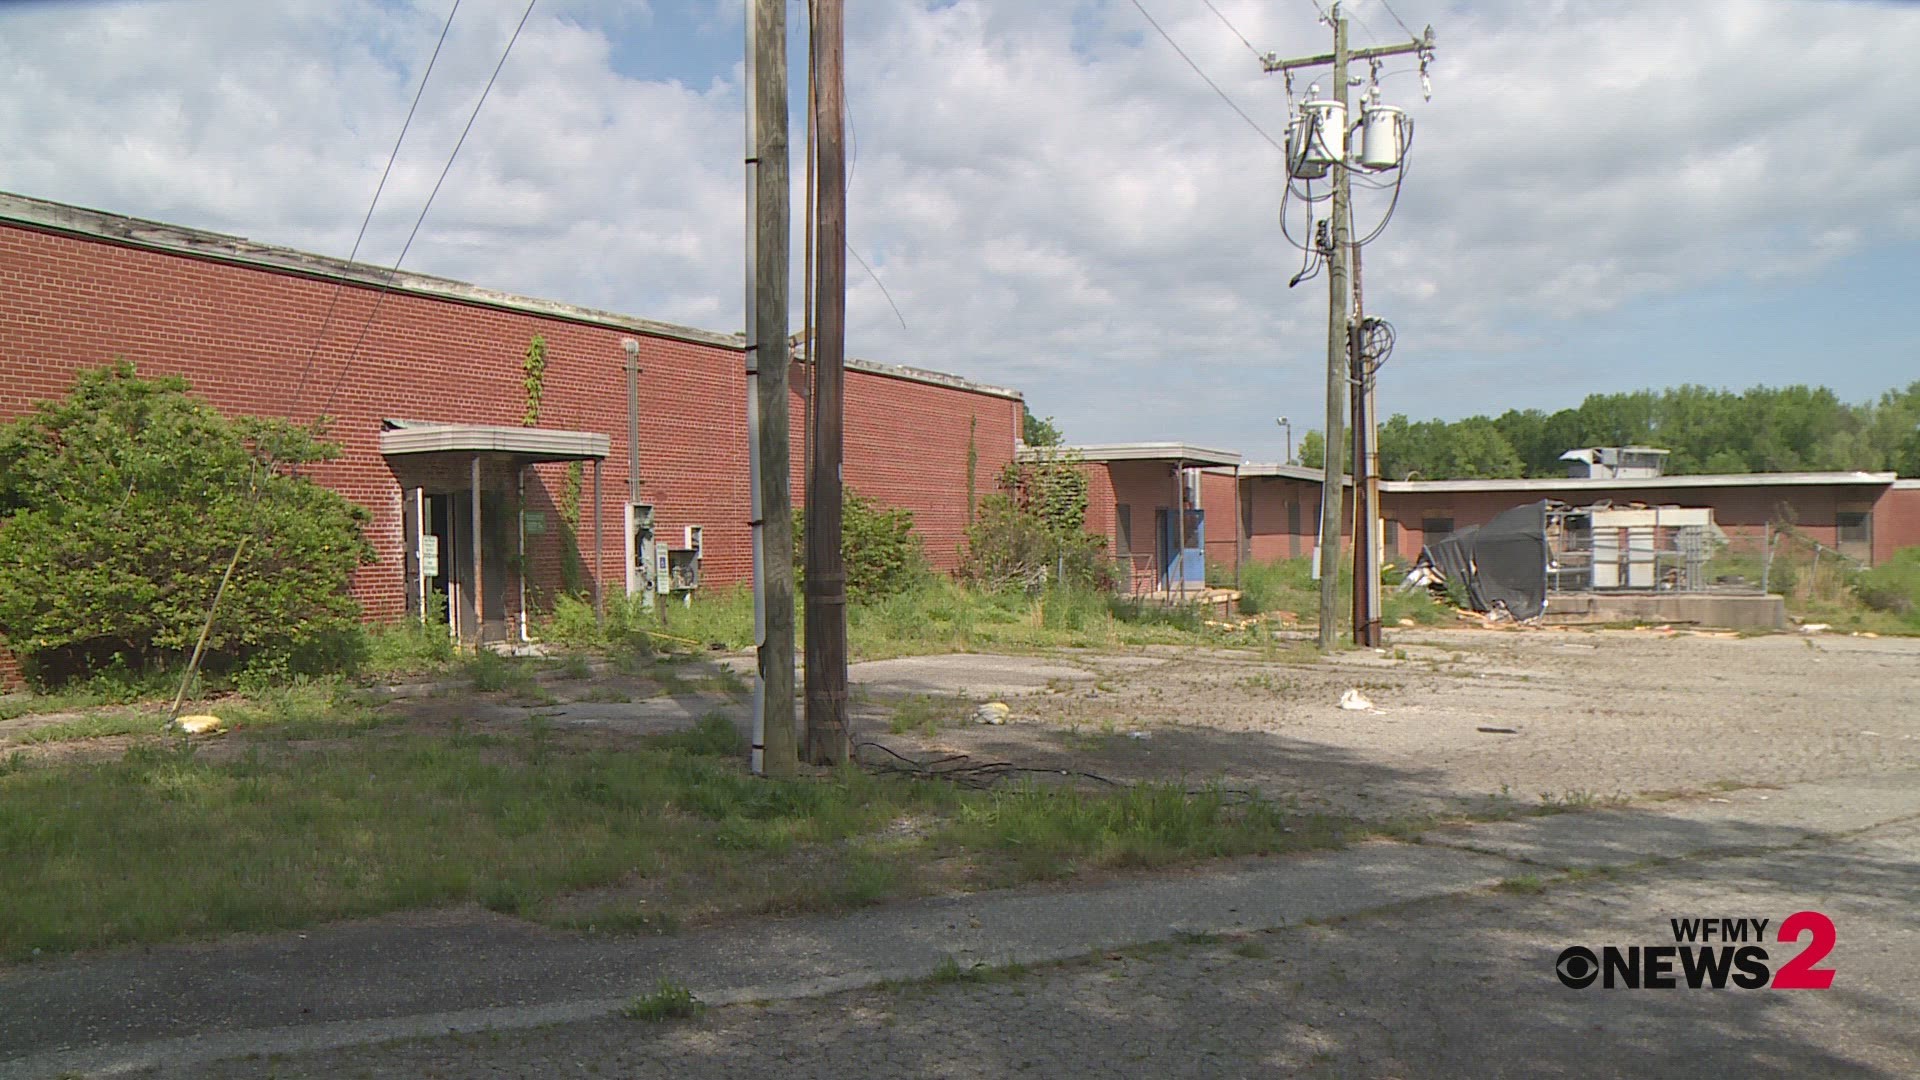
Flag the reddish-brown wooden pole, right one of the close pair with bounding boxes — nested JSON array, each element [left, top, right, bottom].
[[806, 0, 852, 765]]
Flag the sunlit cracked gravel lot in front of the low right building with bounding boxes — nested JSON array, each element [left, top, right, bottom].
[[877, 630, 1920, 815]]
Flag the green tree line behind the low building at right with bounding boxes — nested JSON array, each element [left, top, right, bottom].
[[1300, 382, 1920, 480]]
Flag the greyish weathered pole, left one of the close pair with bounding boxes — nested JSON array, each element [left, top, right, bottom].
[[747, 0, 799, 776]]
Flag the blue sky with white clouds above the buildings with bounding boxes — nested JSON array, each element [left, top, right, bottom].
[[0, 0, 1920, 459]]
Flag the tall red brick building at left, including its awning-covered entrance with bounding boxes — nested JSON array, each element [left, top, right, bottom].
[[0, 194, 1021, 664]]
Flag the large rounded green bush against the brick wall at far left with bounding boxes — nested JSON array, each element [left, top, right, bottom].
[[0, 363, 372, 684]]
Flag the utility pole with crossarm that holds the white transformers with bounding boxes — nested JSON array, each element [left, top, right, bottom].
[[1263, 2, 1432, 650]]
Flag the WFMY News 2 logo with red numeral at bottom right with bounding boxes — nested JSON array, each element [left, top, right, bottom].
[[1553, 911, 1836, 990]]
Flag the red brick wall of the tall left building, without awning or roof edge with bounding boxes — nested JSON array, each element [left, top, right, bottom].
[[0, 214, 1020, 676]]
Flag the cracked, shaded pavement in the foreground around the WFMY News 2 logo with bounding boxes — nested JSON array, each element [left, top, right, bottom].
[[168, 822, 1920, 1080]]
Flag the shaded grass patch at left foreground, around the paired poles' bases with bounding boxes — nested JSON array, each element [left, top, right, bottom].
[[0, 699, 1373, 959]]
